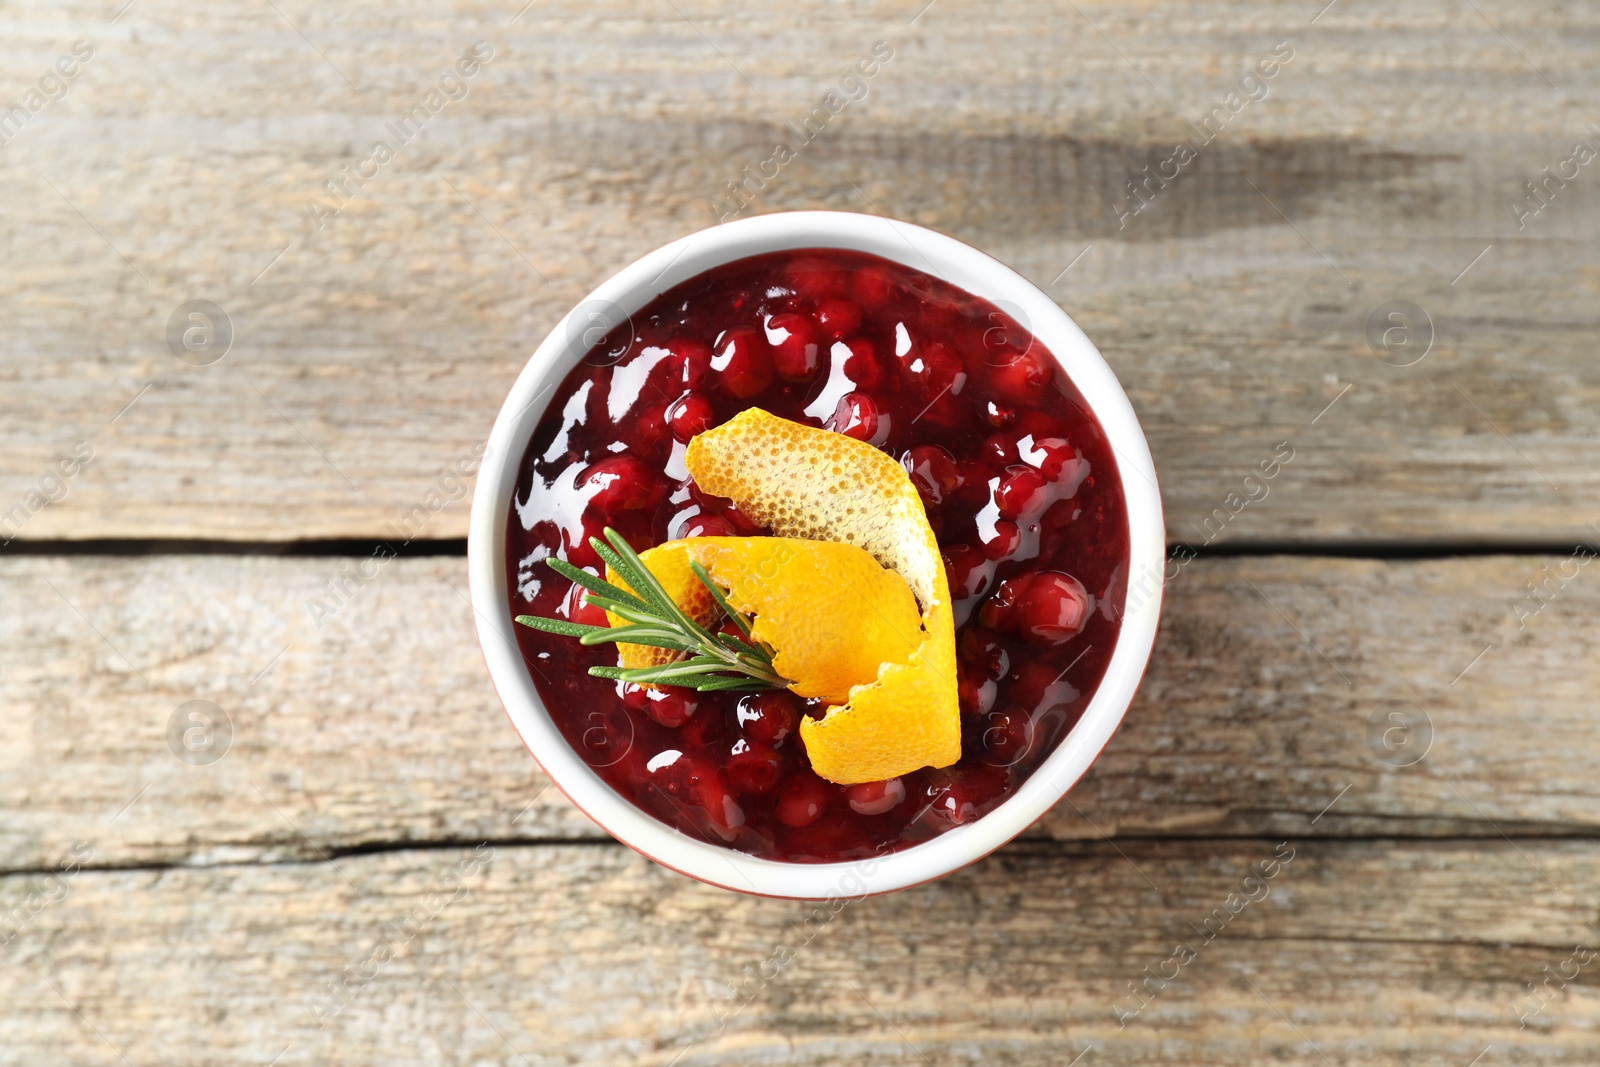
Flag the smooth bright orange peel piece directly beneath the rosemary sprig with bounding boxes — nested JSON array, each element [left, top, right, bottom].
[[608, 537, 922, 704]]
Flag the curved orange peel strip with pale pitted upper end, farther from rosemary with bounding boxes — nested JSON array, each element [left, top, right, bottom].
[[681, 408, 962, 785]]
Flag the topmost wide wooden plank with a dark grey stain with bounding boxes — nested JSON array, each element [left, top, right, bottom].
[[0, 0, 1600, 544]]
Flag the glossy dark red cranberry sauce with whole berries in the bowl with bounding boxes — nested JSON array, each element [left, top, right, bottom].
[[506, 250, 1128, 862]]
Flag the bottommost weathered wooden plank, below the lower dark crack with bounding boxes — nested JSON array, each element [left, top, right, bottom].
[[0, 840, 1600, 1067]]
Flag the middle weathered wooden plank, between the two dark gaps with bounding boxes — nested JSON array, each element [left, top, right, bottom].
[[0, 555, 1600, 870]]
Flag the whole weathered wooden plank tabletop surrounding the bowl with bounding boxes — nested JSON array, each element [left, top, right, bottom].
[[0, 0, 1600, 1067]]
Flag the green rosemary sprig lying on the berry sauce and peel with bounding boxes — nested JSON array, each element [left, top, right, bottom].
[[517, 526, 789, 693]]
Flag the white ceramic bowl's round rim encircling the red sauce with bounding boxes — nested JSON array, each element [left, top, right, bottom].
[[467, 211, 1166, 899]]
